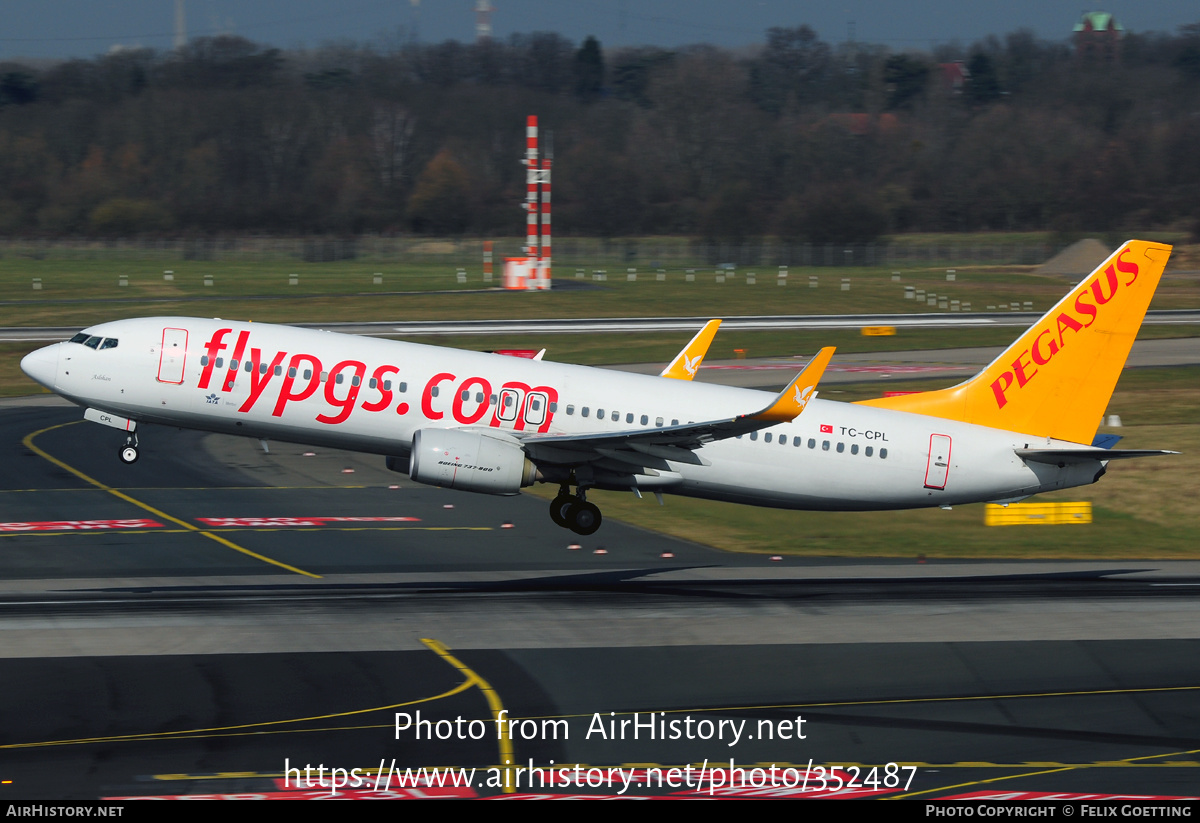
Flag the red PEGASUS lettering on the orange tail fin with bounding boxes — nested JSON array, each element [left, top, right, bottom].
[[991, 247, 1138, 409]]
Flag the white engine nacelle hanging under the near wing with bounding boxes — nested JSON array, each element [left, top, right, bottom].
[[408, 428, 538, 494]]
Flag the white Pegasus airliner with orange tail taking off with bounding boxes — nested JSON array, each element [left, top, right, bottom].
[[22, 241, 1171, 534]]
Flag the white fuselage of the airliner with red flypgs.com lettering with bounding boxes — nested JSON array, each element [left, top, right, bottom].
[[23, 318, 1103, 510]]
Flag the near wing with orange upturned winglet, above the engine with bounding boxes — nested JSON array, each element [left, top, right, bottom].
[[521, 347, 834, 476]]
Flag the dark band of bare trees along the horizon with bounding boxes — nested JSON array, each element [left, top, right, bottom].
[[0, 24, 1200, 242]]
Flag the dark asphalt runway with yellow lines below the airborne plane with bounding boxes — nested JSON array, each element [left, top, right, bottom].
[[0, 398, 1200, 801]]
